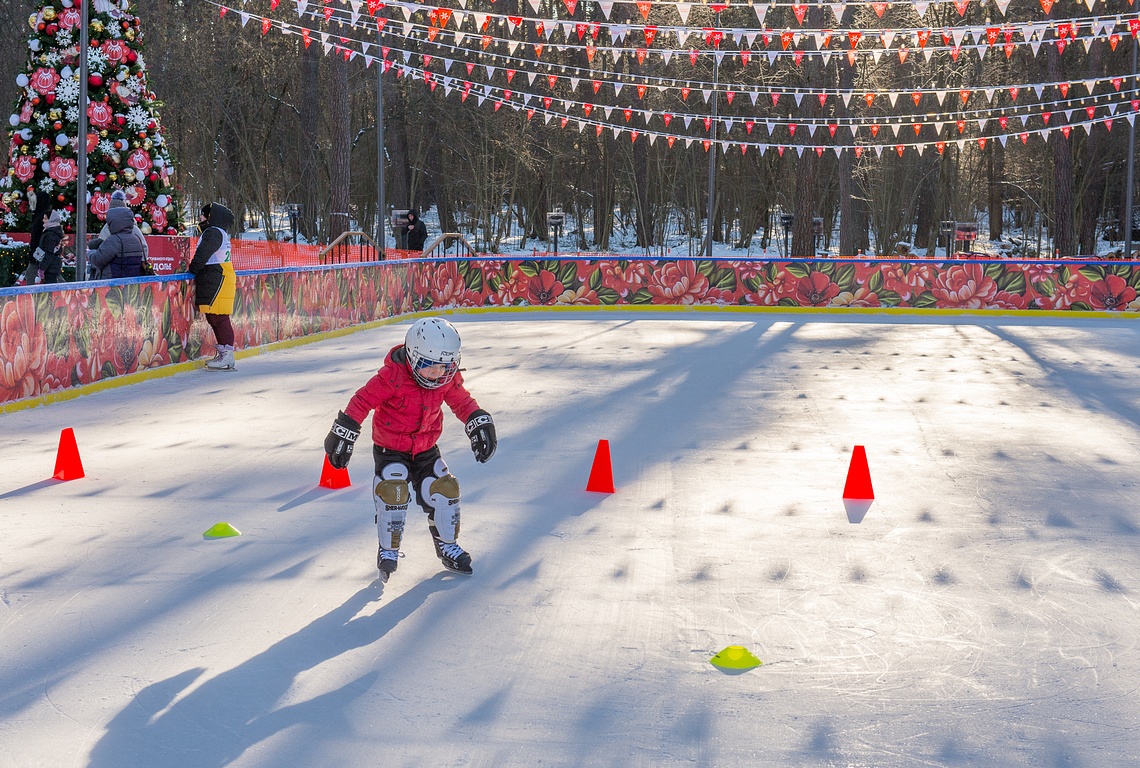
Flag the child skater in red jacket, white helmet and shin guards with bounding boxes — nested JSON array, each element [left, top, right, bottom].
[[325, 318, 498, 581]]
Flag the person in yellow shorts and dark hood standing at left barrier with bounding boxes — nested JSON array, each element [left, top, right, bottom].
[[189, 203, 237, 370]]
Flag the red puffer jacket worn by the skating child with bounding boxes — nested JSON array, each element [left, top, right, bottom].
[[344, 344, 479, 454]]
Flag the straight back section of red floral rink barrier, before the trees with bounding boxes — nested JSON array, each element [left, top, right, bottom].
[[416, 259, 1140, 311]]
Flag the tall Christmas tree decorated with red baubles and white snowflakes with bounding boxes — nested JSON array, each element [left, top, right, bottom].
[[0, 0, 180, 235]]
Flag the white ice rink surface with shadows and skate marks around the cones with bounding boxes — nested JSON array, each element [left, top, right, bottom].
[[0, 312, 1140, 768]]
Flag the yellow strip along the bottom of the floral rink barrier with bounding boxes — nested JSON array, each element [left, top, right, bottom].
[[0, 298, 1140, 414]]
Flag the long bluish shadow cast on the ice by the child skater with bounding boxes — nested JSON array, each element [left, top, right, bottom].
[[89, 573, 462, 768]]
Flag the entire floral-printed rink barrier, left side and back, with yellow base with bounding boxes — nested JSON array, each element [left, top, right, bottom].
[[0, 256, 1140, 412]]
